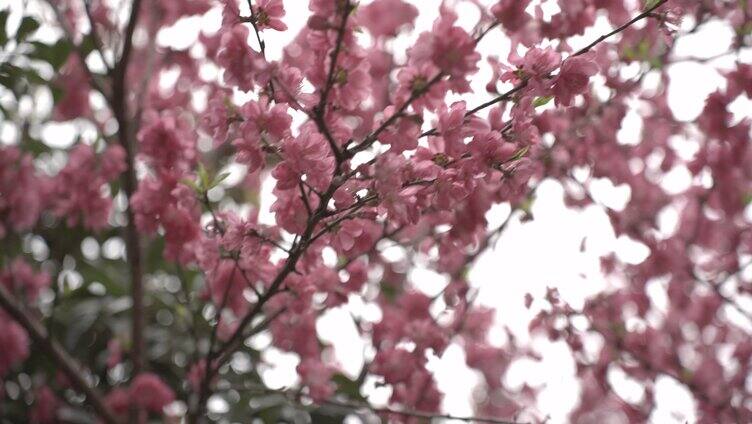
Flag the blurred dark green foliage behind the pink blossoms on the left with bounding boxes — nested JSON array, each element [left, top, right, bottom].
[[0, 6, 362, 424]]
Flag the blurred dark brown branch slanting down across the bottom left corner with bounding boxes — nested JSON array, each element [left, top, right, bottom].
[[0, 284, 119, 424]]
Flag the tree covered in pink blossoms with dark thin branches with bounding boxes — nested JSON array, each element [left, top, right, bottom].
[[0, 0, 752, 424]]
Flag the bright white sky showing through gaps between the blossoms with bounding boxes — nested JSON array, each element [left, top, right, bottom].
[[0, 0, 752, 423]]
